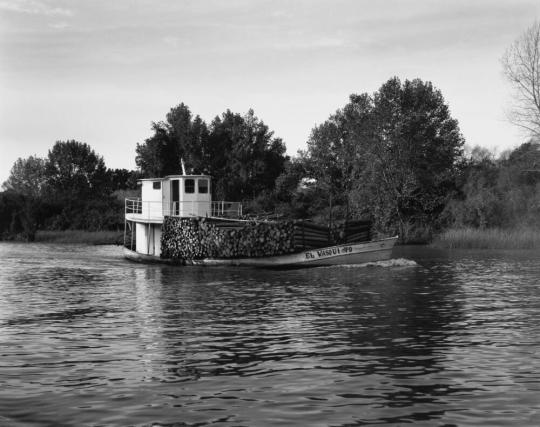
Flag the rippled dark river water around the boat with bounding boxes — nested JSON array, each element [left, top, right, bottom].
[[0, 243, 540, 426]]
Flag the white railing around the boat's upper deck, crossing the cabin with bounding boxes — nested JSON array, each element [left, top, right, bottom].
[[124, 198, 242, 220]]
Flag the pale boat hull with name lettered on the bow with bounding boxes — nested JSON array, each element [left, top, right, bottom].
[[124, 237, 397, 268]]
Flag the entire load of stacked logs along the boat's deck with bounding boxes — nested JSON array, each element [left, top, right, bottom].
[[161, 217, 371, 260]]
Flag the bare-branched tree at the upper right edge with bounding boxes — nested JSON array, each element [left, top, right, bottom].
[[502, 21, 540, 137]]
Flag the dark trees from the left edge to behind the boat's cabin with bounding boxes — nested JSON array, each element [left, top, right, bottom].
[[0, 104, 289, 241]]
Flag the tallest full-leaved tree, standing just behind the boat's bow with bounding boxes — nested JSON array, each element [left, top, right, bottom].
[[372, 78, 464, 233]]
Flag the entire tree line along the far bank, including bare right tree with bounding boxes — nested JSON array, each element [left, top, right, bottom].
[[4, 15, 540, 242]]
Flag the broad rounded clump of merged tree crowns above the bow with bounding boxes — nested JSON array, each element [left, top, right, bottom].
[[306, 78, 463, 236]]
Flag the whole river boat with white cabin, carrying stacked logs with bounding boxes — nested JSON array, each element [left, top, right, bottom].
[[124, 172, 397, 268]]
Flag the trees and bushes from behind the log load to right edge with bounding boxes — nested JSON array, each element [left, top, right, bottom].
[[272, 78, 540, 242]]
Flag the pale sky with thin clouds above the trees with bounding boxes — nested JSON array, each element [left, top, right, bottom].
[[0, 0, 540, 183]]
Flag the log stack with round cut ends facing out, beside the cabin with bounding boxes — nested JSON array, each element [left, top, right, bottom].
[[161, 217, 294, 260]]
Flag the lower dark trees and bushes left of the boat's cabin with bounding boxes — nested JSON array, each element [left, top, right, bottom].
[[0, 140, 139, 240]]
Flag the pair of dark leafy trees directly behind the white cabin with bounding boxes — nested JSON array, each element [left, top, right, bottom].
[[136, 104, 287, 201]]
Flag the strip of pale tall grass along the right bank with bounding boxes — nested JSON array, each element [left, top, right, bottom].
[[433, 227, 540, 249]]
